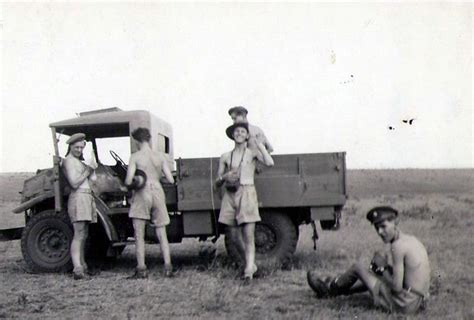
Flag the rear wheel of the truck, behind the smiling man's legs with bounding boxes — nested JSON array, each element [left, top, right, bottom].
[[225, 211, 298, 268]]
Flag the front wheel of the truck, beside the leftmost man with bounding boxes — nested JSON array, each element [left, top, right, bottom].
[[21, 210, 73, 272]]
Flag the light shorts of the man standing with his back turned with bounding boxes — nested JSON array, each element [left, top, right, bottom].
[[128, 184, 170, 227]]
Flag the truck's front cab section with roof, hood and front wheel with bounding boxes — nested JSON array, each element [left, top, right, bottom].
[[13, 108, 179, 271]]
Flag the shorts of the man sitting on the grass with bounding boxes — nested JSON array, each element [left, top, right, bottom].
[[373, 280, 424, 313]]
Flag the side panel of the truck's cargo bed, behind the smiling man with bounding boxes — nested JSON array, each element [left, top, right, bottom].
[[177, 152, 346, 216]]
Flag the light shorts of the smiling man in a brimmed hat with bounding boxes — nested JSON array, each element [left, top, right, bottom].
[[219, 185, 261, 226]]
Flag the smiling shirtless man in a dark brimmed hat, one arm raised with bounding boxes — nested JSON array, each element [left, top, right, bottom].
[[215, 122, 273, 281]]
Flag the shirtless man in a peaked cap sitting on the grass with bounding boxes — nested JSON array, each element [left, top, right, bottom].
[[308, 207, 430, 314]]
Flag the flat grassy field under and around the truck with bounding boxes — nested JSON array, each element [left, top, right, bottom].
[[0, 170, 474, 319]]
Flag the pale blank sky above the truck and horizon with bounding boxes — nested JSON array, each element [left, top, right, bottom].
[[0, 3, 474, 172]]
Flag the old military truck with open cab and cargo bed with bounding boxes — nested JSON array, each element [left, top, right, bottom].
[[3, 108, 346, 272]]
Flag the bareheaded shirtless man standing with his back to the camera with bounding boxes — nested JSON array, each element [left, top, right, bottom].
[[125, 128, 174, 279]]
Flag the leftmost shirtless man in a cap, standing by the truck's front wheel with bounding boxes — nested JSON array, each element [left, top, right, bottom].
[[62, 133, 97, 279]]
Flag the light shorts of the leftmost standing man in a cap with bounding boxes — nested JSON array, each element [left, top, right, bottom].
[[67, 189, 97, 223]]
